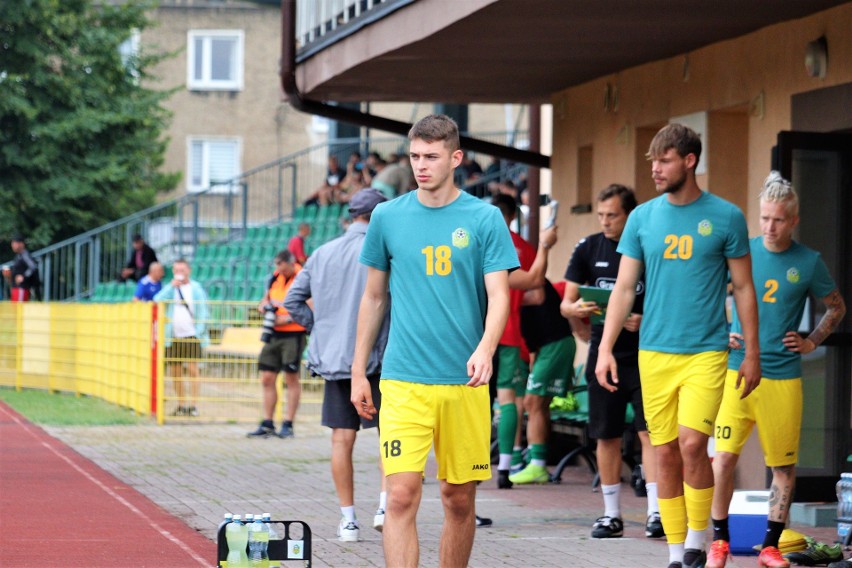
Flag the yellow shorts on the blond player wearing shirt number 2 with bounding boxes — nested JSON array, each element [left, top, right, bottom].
[[716, 369, 802, 467]]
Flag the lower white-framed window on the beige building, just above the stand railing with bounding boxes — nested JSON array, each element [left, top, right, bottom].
[[186, 137, 240, 192]]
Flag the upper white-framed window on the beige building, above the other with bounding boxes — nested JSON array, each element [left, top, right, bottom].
[[186, 30, 244, 91]]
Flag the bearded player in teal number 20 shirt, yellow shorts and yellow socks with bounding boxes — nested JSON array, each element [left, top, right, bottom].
[[595, 124, 760, 568]]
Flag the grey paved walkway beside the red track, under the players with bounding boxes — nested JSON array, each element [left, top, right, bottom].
[[40, 414, 833, 568]]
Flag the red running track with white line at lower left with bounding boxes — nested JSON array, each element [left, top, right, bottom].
[[0, 402, 216, 568]]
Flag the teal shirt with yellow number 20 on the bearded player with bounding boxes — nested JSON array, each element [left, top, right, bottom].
[[618, 192, 748, 354]]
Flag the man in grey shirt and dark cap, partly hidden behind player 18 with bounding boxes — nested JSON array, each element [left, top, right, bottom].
[[284, 188, 390, 542]]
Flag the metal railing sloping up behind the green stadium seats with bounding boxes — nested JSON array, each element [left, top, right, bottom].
[[0, 132, 518, 301]]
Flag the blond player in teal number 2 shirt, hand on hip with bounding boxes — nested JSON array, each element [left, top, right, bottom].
[[707, 172, 846, 568]]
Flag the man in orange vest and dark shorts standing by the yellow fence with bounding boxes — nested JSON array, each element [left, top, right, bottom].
[[247, 250, 305, 438]]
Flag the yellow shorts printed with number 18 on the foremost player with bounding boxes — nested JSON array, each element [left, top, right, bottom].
[[379, 379, 491, 484]]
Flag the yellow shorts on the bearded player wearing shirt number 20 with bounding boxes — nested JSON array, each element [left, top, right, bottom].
[[639, 350, 728, 446]]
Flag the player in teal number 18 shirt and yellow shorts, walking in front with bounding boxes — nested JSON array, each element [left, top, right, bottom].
[[352, 115, 518, 567]]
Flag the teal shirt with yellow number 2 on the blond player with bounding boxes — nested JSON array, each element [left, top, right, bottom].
[[728, 237, 837, 379]]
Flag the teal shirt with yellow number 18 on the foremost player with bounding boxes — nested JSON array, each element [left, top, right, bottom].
[[360, 191, 518, 384]]
